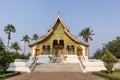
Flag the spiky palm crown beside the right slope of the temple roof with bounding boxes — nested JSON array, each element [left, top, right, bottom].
[[78, 27, 95, 42]]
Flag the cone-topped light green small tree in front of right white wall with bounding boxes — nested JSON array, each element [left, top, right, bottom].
[[102, 49, 118, 73]]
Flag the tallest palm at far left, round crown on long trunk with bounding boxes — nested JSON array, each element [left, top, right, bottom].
[[4, 24, 16, 51]]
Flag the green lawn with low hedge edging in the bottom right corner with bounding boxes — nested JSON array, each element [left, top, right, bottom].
[[93, 70, 120, 80]]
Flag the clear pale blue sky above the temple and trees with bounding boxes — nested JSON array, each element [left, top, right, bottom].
[[0, 0, 120, 55]]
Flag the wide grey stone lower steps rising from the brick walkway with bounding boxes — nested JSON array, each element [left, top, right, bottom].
[[33, 63, 81, 72]]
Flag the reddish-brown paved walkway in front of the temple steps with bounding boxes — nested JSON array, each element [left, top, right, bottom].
[[5, 72, 107, 80]]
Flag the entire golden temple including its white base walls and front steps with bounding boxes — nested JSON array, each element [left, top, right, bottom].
[[8, 15, 109, 72]]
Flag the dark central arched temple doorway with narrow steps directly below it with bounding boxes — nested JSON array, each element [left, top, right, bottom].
[[53, 40, 64, 62]]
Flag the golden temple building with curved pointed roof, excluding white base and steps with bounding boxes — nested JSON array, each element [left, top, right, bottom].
[[29, 15, 89, 58]]
